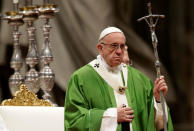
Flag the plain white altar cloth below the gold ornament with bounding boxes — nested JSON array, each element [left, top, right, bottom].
[[0, 106, 64, 131]]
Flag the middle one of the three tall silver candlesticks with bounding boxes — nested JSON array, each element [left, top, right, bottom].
[[20, 0, 40, 93]]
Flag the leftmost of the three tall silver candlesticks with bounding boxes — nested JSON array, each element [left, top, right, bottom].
[[4, 0, 24, 95]]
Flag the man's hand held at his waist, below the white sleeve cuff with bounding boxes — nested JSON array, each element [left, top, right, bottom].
[[117, 106, 134, 122]]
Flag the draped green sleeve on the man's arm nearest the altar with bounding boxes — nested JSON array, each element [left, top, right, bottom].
[[65, 69, 104, 131]]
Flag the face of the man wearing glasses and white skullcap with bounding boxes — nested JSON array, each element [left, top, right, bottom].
[[97, 33, 126, 67]]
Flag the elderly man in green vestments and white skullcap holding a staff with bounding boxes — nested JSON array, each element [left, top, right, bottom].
[[65, 27, 173, 131]]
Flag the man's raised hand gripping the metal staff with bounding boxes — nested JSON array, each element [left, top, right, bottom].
[[154, 76, 168, 102]]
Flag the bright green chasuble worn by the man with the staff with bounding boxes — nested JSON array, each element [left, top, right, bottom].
[[65, 65, 173, 131]]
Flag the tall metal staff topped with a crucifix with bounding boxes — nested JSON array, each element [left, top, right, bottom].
[[137, 3, 168, 131]]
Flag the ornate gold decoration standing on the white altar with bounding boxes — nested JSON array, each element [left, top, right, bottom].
[[1, 84, 52, 106]]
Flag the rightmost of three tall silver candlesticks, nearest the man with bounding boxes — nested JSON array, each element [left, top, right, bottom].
[[38, 1, 58, 101]]
